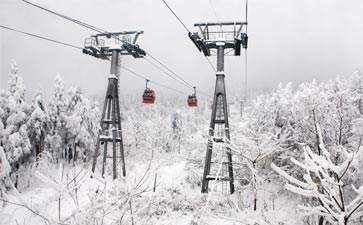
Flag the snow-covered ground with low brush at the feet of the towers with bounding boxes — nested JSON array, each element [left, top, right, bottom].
[[0, 107, 302, 225]]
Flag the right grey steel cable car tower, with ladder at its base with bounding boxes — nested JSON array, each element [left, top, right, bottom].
[[189, 22, 248, 194]]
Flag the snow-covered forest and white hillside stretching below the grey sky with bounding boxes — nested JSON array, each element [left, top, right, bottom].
[[0, 62, 363, 225]]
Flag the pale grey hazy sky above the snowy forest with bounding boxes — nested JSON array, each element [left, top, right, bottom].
[[0, 0, 363, 100]]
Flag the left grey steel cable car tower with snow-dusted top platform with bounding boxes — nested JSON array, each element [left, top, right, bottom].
[[83, 31, 146, 179]]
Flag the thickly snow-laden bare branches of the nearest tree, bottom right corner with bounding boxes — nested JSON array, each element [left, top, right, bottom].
[[272, 125, 363, 225]]
